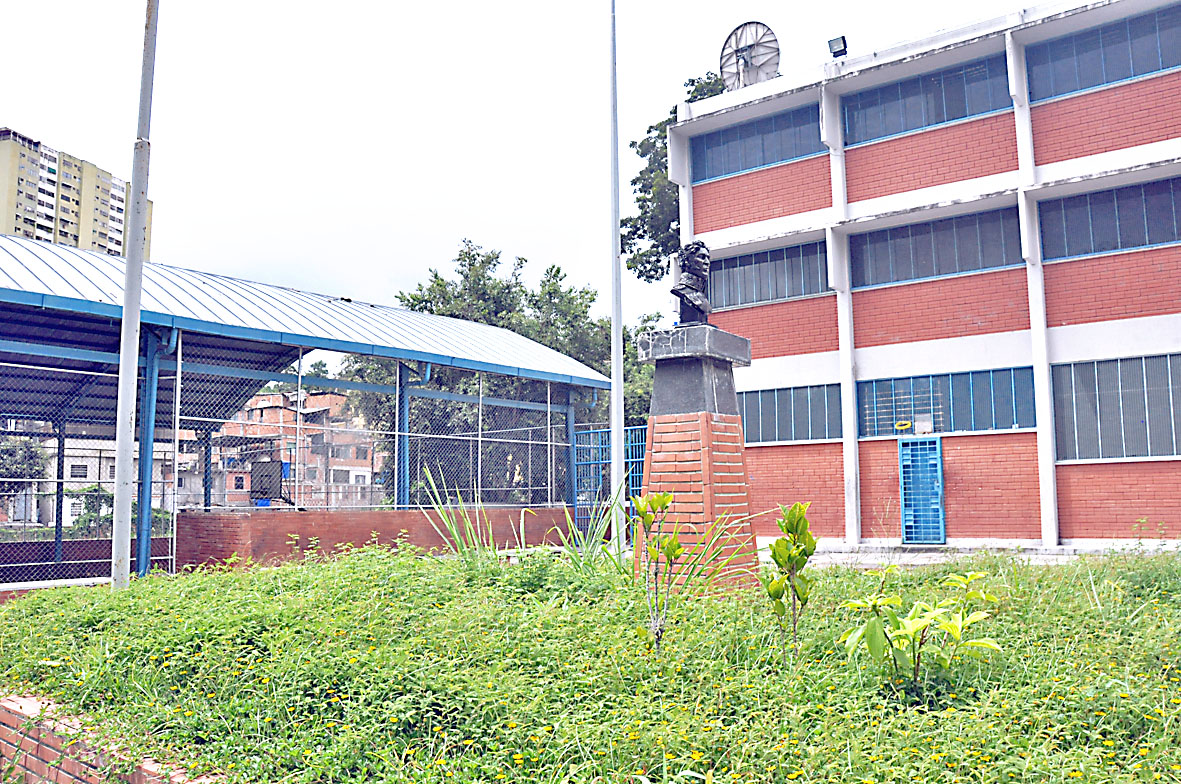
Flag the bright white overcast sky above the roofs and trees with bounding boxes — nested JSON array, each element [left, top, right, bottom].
[[0, 0, 1025, 321]]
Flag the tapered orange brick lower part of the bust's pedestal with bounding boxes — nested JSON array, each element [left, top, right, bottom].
[[637, 412, 758, 580]]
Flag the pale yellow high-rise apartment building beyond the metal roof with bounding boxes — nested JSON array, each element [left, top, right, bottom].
[[0, 128, 152, 259]]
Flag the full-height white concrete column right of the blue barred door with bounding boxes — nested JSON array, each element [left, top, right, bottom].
[[1005, 32, 1059, 547]]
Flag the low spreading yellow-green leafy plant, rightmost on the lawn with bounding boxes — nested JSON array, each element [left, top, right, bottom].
[[840, 566, 1000, 693]]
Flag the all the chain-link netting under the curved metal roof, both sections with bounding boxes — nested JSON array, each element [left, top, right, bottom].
[[0, 344, 579, 584]]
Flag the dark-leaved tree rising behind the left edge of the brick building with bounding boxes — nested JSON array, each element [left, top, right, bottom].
[[620, 71, 725, 281]]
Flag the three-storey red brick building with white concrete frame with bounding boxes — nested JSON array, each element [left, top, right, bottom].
[[670, 0, 1181, 545]]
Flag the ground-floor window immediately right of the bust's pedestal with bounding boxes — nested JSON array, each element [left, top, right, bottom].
[[738, 384, 841, 444]]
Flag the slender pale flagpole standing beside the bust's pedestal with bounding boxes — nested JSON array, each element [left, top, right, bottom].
[[611, 0, 624, 549]]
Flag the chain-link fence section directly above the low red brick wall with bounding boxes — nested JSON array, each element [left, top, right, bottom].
[[177, 354, 574, 510]]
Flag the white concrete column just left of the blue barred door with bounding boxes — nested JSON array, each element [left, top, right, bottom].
[[820, 85, 861, 547]]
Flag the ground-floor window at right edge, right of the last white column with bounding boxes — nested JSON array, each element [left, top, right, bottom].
[[1051, 354, 1181, 460]]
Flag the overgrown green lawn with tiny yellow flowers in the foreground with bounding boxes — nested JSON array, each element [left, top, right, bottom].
[[0, 548, 1181, 784]]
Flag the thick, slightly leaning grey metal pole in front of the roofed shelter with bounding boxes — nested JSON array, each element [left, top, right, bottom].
[[111, 0, 159, 590]]
